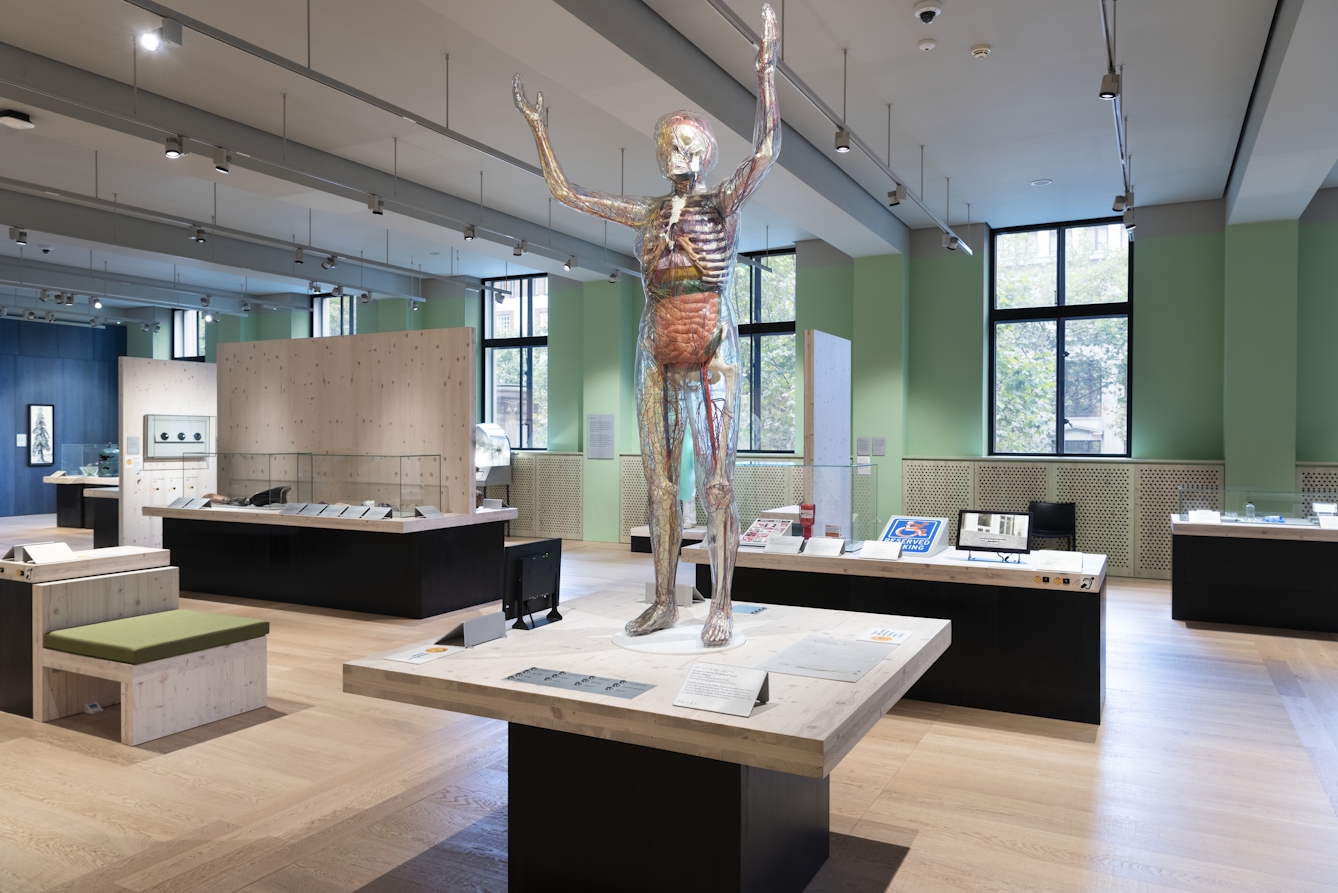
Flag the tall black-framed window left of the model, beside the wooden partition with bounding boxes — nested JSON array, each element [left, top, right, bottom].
[[482, 276, 549, 450]]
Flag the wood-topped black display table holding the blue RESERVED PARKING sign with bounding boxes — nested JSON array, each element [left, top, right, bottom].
[[682, 545, 1105, 723]]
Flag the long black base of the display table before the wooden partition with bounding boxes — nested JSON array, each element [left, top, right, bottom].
[[163, 518, 504, 619]]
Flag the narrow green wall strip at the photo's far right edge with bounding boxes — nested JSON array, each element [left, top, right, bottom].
[[1297, 222, 1338, 462]]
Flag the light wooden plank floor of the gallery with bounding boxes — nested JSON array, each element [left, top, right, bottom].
[[0, 517, 1338, 893]]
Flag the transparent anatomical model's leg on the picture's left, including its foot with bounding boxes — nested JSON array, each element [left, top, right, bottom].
[[626, 317, 685, 636]]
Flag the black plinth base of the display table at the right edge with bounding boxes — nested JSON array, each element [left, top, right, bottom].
[[1171, 534, 1338, 632]]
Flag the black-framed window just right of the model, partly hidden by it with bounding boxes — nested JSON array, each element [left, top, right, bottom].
[[733, 248, 795, 453]]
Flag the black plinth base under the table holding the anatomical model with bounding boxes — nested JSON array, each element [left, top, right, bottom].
[[507, 723, 831, 893]]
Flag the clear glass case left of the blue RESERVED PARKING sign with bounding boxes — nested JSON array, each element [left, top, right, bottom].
[[735, 459, 883, 549]]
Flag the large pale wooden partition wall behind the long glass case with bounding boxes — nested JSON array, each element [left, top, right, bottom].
[[218, 328, 478, 513]]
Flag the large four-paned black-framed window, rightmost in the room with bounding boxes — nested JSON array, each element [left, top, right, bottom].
[[990, 220, 1133, 455]]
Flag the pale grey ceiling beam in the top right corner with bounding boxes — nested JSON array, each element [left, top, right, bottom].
[[1226, 0, 1338, 224]]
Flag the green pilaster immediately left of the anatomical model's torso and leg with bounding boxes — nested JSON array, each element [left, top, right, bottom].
[[578, 278, 644, 542]]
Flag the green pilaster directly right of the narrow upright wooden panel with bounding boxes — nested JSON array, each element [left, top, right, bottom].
[[851, 254, 910, 522]]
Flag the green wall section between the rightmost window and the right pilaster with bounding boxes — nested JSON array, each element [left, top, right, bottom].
[[1131, 232, 1226, 459]]
